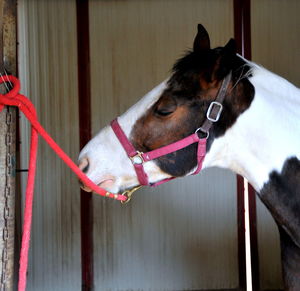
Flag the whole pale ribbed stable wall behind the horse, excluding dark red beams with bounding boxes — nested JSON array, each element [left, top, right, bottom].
[[18, 0, 300, 291]]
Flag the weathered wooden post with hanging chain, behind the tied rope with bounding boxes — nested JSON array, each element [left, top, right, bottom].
[[0, 0, 16, 291]]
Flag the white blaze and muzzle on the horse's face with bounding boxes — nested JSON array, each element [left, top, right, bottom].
[[79, 81, 169, 193]]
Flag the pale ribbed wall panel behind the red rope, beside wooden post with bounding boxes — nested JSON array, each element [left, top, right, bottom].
[[18, 0, 81, 291]]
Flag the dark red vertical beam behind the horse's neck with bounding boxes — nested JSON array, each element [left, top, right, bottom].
[[233, 0, 260, 291]]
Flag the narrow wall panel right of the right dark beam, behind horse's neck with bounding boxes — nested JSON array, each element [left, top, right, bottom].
[[251, 0, 300, 290]]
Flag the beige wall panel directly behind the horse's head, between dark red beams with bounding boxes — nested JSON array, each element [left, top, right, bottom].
[[90, 0, 238, 290]]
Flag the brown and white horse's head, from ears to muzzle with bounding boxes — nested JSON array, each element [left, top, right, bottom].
[[79, 24, 254, 193]]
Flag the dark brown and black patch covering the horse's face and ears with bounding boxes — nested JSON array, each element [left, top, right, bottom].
[[131, 25, 254, 176]]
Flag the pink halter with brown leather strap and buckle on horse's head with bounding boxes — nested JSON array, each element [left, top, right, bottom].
[[111, 71, 231, 187]]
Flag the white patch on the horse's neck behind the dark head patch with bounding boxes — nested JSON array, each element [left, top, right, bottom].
[[204, 65, 300, 191]]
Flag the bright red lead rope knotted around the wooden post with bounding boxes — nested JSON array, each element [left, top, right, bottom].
[[0, 76, 127, 291]]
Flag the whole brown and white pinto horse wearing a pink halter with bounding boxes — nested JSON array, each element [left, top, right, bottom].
[[78, 24, 300, 291]]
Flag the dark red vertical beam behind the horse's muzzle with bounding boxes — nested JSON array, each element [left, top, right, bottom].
[[76, 0, 94, 291]]
